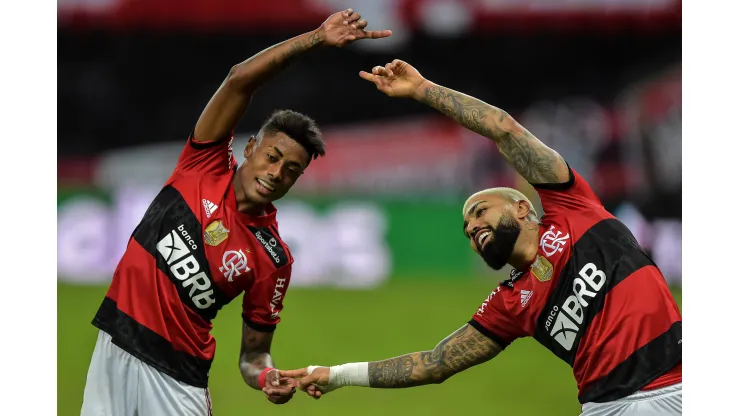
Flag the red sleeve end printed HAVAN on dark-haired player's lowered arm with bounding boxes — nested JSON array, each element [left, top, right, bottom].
[[242, 267, 290, 332]]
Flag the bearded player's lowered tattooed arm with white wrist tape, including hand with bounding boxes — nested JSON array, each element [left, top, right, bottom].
[[280, 324, 501, 397]]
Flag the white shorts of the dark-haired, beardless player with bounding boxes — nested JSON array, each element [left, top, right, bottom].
[[81, 331, 212, 416]]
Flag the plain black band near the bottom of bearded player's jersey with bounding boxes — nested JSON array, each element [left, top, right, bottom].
[[578, 321, 683, 403]]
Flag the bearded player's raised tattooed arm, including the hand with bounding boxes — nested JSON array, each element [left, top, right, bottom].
[[360, 59, 570, 184]]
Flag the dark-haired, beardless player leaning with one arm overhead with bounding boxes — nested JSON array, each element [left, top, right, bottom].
[[82, 9, 391, 416]]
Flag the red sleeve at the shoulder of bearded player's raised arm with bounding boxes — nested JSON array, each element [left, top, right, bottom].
[[532, 162, 603, 214]]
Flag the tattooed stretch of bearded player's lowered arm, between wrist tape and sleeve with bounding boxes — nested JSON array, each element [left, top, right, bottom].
[[368, 325, 501, 388]]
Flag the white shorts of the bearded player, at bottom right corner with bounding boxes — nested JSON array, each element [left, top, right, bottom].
[[581, 383, 683, 416]]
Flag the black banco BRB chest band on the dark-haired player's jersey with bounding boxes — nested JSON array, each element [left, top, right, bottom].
[[133, 186, 231, 321]]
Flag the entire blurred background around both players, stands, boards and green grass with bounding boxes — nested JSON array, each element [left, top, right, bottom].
[[57, 0, 682, 416]]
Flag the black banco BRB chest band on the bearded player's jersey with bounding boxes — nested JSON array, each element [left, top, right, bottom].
[[534, 219, 654, 366]]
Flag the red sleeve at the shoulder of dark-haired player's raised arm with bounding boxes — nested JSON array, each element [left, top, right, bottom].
[[175, 132, 236, 175]]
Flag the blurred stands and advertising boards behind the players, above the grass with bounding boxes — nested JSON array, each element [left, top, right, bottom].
[[57, 0, 681, 288]]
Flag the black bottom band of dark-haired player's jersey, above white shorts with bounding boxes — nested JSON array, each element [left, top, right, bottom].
[[92, 297, 211, 388]]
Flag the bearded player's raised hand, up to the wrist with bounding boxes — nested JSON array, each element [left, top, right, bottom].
[[360, 59, 425, 99]]
